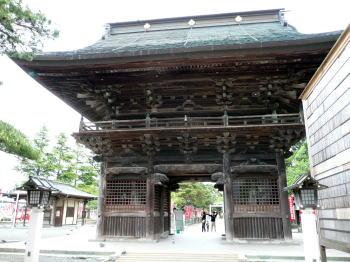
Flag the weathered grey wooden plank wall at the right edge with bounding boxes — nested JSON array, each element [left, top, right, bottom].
[[303, 40, 350, 252]]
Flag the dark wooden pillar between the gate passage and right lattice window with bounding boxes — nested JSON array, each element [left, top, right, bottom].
[[222, 151, 234, 241]]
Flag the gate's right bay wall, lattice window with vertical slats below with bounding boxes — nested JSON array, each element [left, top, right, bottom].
[[232, 173, 289, 239]]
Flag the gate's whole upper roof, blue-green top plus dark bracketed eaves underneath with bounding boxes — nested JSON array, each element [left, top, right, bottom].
[[16, 9, 339, 121]]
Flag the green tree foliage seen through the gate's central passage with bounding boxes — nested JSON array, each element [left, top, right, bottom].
[[171, 183, 222, 209]]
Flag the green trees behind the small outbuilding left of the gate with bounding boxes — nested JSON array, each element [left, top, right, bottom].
[[17, 127, 99, 201]]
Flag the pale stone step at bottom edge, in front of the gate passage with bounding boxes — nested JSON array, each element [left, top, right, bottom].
[[116, 252, 246, 262]]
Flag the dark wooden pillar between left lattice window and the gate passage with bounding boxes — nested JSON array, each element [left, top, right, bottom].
[[146, 154, 155, 239]]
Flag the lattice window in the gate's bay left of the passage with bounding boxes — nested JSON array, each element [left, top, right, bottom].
[[105, 179, 147, 211]]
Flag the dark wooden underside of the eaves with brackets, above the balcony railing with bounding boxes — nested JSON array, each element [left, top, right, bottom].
[[21, 49, 328, 121]]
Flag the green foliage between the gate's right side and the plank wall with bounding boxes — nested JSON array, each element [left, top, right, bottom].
[[286, 139, 310, 185]]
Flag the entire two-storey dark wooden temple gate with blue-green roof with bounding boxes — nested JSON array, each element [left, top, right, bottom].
[[16, 10, 339, 240]]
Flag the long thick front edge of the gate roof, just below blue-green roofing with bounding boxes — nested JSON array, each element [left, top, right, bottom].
[[15, 32, 341, 69]]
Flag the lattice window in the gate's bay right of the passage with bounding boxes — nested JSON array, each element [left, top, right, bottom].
[[233, 178, 279, 212]]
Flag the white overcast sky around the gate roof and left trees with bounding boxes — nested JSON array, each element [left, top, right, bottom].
[[0, 0, 350, 191]]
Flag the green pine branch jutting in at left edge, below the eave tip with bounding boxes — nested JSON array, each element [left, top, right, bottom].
[[0, 120, 39, 159]]
